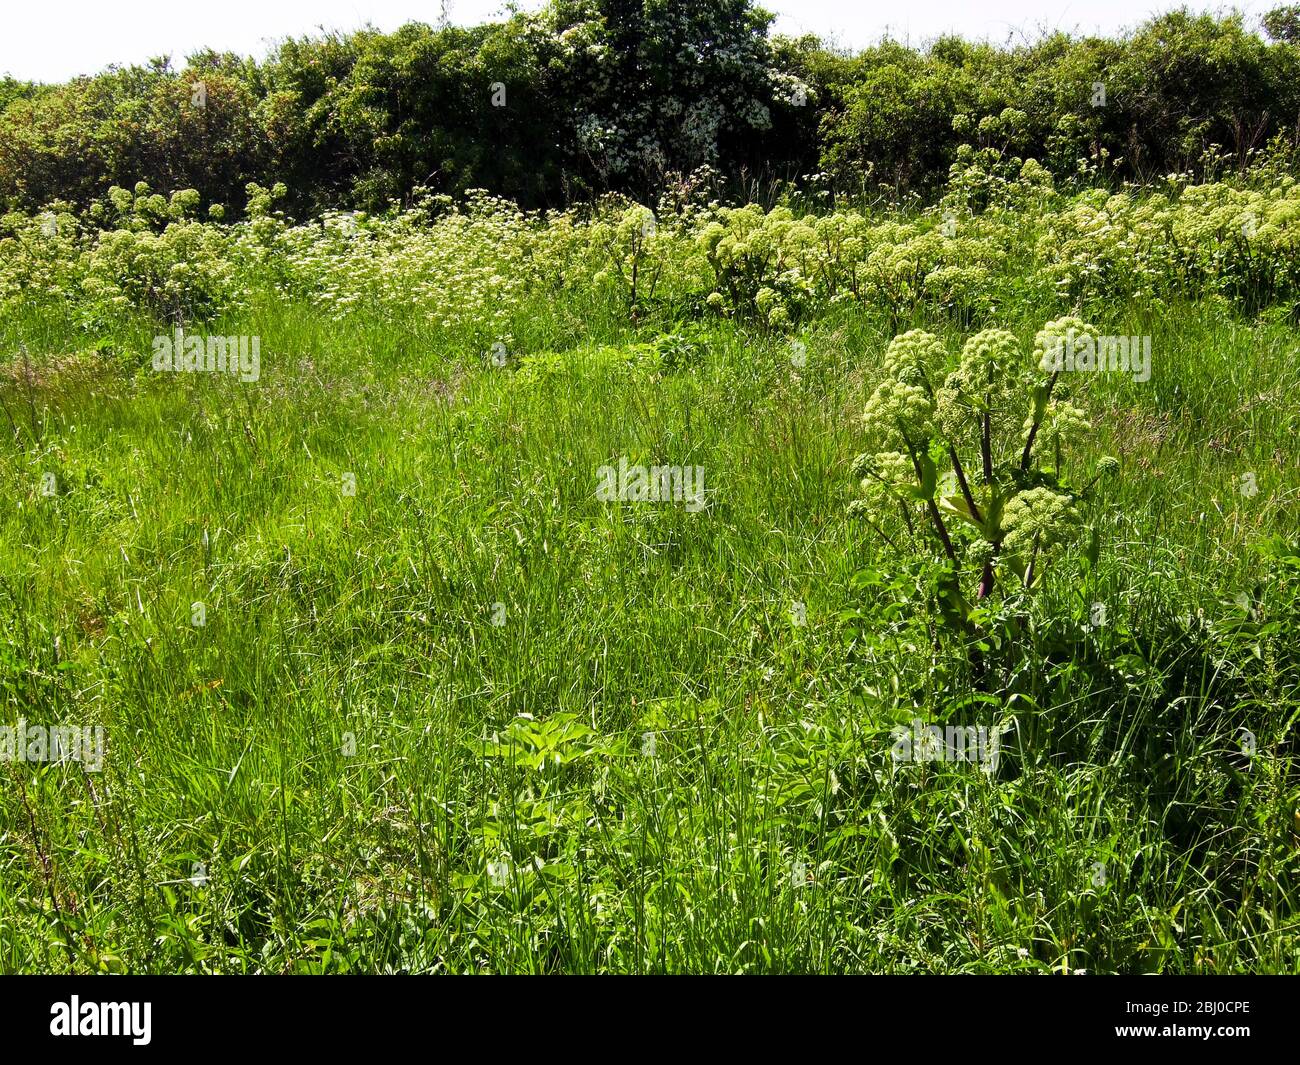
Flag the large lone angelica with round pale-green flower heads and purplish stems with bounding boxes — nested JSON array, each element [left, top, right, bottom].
[[853, 317, 1118, 619]]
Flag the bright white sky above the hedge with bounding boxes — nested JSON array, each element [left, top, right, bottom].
[[0, 0, 1282, 81]]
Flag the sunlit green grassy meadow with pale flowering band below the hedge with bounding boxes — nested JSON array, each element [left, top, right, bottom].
[[0, 166, 1300, 974]]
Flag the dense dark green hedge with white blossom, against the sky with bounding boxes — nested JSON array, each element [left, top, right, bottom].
[[0, 0, 1300, 215]]
